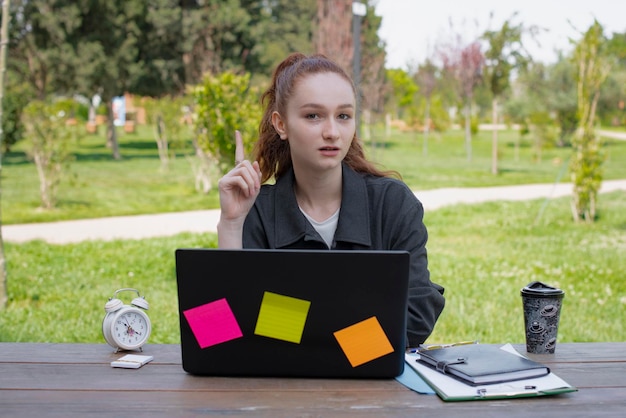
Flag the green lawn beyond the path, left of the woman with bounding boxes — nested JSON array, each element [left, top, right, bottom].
[[2, 127, 219, 224]]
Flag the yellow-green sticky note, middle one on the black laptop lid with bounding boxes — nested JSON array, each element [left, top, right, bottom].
[[254, 292, 311, 344]]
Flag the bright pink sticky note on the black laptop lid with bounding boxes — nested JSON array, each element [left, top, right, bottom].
[[183, 299, 243, 348]]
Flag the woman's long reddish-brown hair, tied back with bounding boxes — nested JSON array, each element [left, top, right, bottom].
[[254, 52, 400, 183]]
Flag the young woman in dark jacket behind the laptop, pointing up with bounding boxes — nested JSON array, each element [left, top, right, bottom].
[[217, 53, 444, 347]]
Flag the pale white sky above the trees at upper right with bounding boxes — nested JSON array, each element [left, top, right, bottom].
[[375, 0, 626, 69]]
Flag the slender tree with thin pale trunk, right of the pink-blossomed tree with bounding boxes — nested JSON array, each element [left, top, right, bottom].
[[482, 13, 529, 174]]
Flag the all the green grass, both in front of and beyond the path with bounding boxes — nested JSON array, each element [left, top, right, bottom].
[[0, 122, 626, 343]]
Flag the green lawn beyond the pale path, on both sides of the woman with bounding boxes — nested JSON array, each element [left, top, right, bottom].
[[1, 126, 626, 225]]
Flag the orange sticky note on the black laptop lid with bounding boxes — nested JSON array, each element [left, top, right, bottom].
[[333, 316, 393, 367]]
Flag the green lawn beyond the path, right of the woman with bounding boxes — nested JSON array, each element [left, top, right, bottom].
[[369, 126, 626, 190]]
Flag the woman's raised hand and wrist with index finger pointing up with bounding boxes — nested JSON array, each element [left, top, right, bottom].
[[218, 131, 261, 248]]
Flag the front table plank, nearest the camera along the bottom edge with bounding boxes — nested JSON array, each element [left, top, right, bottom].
[[0, 389, 626, 418]]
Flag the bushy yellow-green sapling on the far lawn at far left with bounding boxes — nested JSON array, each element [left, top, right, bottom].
[[23, 99, 79, 209]]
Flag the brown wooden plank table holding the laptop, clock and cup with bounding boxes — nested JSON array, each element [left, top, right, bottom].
[[0, 342, 626, 418]]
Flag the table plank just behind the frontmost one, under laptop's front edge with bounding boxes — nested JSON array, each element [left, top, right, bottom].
[[0, 363, 626, 392]]
